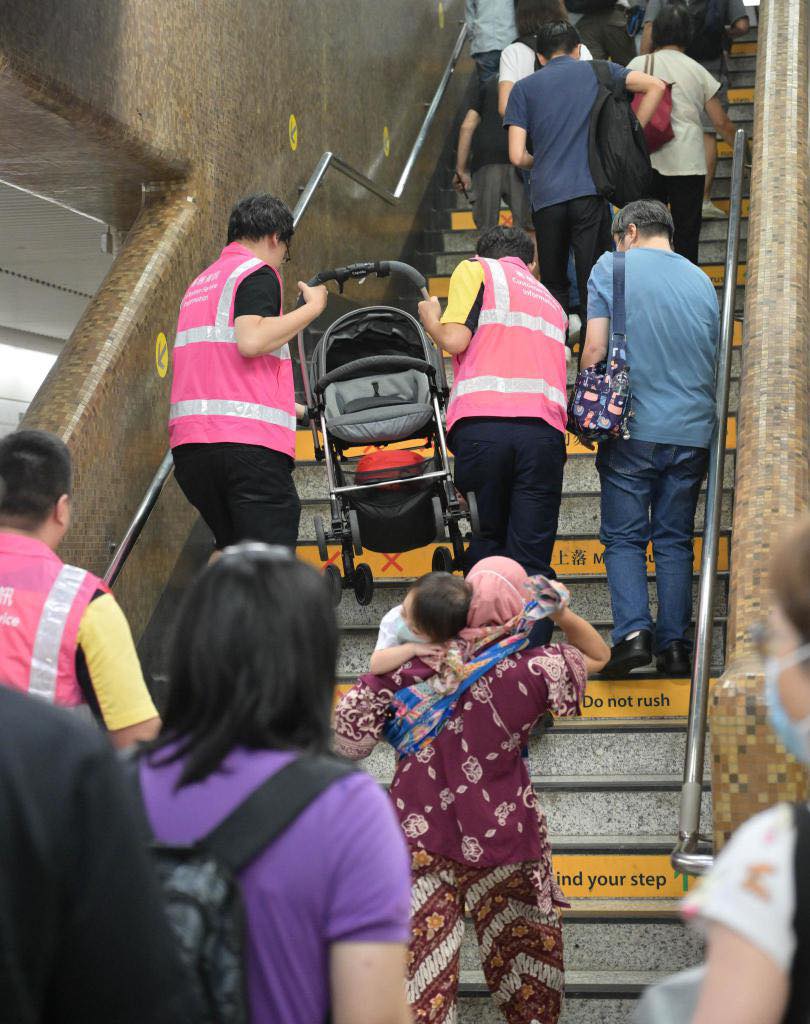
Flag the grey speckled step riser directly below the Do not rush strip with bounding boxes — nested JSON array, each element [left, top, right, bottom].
[[360, 719, 711, 785]]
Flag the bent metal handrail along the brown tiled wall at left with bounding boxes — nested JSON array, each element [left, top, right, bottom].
[[103, 25, 467, 587]]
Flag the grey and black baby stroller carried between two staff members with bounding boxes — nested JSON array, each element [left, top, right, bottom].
[[299, 261, 478, 604]]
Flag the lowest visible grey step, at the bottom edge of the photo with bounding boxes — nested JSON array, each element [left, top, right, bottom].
[[459, 971, 671, 1024]]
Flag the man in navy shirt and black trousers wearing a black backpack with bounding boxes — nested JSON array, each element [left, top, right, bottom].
[[504, 22, 666, 348]]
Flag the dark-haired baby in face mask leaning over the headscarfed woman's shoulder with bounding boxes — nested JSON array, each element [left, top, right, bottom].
[[369, 572, 472, 676]]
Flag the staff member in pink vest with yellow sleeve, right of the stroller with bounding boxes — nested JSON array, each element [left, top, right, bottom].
[[419, 226, 567, 643]]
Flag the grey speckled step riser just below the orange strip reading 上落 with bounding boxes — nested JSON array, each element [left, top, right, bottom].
[[325, 573, 728, 629]]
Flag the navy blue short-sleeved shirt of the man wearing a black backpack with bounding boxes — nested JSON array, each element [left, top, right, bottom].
[[504, 56, 630, 210]]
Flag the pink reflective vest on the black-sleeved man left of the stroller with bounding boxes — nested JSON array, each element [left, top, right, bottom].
[[169, 242, 296, 458]]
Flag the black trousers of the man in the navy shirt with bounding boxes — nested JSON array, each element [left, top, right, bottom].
[[531, 196, 610, 333]]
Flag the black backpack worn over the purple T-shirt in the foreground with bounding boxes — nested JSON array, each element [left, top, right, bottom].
[[128, 757, 355, 1024]]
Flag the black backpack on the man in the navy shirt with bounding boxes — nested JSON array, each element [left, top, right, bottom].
[[588, 60, 652, 206]]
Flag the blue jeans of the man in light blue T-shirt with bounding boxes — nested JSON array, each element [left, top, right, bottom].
[[596, 438, 709, 653]]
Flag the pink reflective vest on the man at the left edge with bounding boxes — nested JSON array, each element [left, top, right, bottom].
[[0, 532, 110, 708]]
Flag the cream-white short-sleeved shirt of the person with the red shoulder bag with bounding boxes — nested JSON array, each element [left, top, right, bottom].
[[628, 50, 720, 176]]
